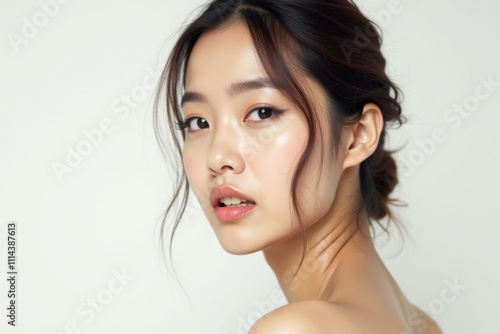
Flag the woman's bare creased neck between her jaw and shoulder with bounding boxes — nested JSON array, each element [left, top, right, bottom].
[[263, 166, 378, 303]]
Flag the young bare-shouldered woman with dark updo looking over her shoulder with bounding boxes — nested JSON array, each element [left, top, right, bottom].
[[155, 0, 441, 334]]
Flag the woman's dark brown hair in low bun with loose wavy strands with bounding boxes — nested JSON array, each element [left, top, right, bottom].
[[154, 0, 405, 276]]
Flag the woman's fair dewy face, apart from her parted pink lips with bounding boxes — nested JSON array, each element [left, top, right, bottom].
[[182, 22, 341, 254]]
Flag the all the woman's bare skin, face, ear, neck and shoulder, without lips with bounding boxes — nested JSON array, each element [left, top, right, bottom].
[[182, 18, 441, 334]]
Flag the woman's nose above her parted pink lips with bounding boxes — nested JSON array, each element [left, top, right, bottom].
[[207, 124, 245, 174]]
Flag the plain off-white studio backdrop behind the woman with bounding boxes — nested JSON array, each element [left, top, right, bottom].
[[0, 0, 500, 334]]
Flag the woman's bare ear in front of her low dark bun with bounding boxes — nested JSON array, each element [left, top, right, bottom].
[[342, 103, 384, 170]]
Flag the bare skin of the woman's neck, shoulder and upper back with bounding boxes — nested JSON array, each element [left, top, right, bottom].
[[250, 168, 442, 334]]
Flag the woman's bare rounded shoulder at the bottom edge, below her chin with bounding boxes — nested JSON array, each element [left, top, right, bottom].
[[249, 300, 377, 334]]
